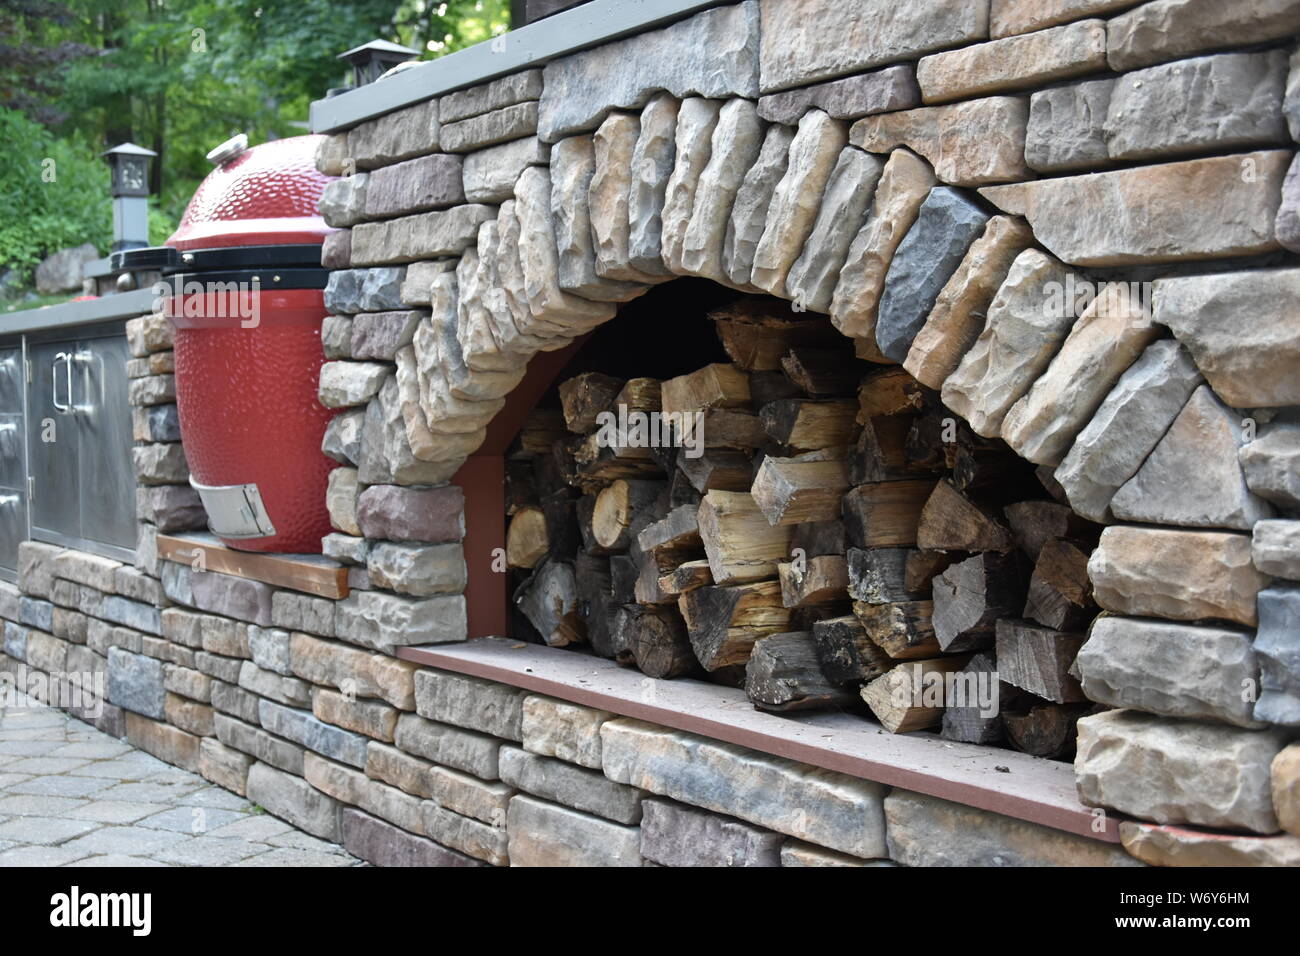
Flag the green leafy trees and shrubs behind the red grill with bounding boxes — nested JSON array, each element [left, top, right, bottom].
[[0, 0, 510, 270]]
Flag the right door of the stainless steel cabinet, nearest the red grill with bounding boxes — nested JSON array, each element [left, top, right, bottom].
[[73, 336, 135, 557]]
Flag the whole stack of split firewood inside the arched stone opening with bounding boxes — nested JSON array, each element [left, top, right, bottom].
[[506, 297, 1099, 757]]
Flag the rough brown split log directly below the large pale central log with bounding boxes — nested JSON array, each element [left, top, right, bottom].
[[677, 581, 790, 671]]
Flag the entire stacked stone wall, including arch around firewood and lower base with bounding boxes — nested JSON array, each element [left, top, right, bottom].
[[0, 0, 1300, 864]]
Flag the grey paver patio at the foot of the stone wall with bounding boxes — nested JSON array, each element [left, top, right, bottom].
[[0, 697, 360, 866]]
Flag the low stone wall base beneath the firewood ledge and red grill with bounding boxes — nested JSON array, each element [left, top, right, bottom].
[[0, 545, 1134, 866]]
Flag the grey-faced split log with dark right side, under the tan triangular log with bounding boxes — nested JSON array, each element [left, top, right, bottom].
[[933, 551, 1026, 653]]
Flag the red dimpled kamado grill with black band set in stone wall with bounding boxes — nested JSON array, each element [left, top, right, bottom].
[[118, 135, 337, 554]]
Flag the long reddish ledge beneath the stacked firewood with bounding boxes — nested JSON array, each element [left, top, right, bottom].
[[397, 637, 1122, 843]]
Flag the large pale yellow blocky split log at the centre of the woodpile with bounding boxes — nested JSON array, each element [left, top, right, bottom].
[[697, 490, 790, 591]]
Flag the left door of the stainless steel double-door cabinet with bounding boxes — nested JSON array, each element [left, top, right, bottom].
[[27, 339, 82, 545]]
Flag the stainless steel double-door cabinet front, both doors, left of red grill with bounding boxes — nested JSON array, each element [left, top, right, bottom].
[[26, 324, 135, 561]]
